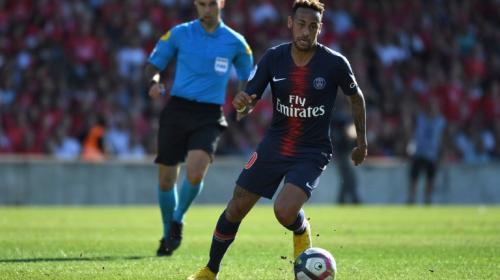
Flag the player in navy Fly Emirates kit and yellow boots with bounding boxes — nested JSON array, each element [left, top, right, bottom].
[[188, 0, 367, 280]]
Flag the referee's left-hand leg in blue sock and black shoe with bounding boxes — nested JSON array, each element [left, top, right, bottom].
[[156, 164, 179, 256]]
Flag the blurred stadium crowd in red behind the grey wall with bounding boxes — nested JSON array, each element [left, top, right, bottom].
[[0, 0, 500, 163]]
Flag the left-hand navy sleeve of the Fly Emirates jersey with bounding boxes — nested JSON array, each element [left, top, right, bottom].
[[245, 50, 272, 99]]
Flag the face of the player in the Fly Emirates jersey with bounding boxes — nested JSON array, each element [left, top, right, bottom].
[[288, 8, 321, 51]]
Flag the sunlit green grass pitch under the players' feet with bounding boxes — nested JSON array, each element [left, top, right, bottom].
[[0, 205, 500, 280]]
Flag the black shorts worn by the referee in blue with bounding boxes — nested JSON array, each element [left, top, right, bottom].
[[155, 96, 227, 165]]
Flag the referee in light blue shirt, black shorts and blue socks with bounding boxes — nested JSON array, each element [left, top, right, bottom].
[[145, 0, 253, 256]]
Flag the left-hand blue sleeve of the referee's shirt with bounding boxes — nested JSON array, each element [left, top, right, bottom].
[[148, 26, 180, 70]]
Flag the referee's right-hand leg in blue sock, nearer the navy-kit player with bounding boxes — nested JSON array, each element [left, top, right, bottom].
[[169, 150, 210, 250]]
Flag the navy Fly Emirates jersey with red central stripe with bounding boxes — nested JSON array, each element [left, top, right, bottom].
[[245, 43, 358, 157]]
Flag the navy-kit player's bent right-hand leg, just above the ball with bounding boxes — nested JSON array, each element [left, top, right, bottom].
[[274, 183, 311, 259]]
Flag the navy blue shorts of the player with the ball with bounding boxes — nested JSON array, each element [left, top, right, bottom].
[[236, 152, 331, 199]]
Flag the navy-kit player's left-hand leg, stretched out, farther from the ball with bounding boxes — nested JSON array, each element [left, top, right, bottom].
[[188, 186, 260, 280]]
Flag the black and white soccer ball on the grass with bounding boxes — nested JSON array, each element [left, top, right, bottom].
[[294, 248, 337, 280]]
